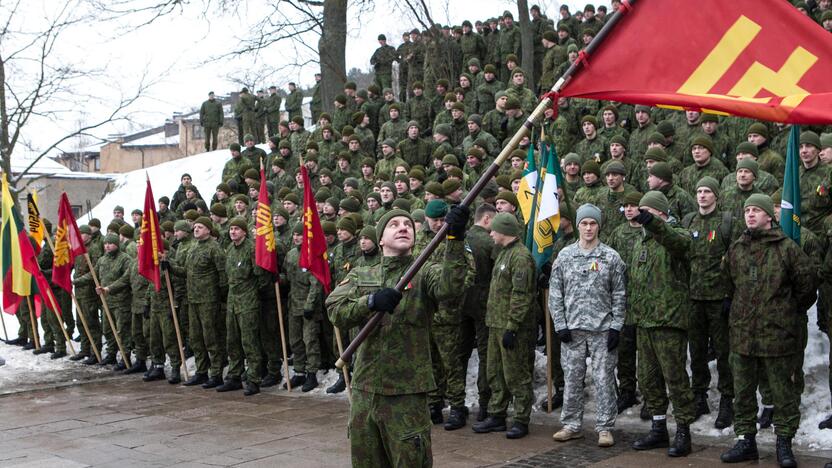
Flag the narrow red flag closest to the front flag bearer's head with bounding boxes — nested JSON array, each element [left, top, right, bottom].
[[296, 165, 331, 294]]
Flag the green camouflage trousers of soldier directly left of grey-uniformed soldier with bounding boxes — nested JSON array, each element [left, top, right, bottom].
[[488, 327, 534, 424]]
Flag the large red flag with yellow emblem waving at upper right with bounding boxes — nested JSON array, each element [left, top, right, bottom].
[[560, 0, 832, 124]]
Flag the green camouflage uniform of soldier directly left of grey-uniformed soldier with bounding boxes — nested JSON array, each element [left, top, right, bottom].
[[485, 239, 536, 424]]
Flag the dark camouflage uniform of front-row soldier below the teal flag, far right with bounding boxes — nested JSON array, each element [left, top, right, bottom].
[[722, 226, 817, 438]]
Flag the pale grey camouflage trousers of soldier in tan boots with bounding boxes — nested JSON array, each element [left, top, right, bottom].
[[560, 330, 618, 432]]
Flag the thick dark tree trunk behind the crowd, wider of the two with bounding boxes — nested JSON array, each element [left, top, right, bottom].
[[318, 0, 347, 115]]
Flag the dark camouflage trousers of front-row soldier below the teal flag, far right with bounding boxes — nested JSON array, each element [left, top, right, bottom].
[[731, 352, 802, 437]]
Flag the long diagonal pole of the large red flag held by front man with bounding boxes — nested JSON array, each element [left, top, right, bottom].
[[335, 0, 637, 369]]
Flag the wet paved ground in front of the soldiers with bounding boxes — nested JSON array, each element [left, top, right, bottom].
[[0, 376, 825, 468]]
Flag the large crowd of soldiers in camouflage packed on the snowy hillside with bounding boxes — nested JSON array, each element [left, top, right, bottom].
[[4, 0, 832, 466]]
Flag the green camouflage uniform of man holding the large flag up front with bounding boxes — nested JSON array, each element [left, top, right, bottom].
[[326, 241, 465, 467]]
